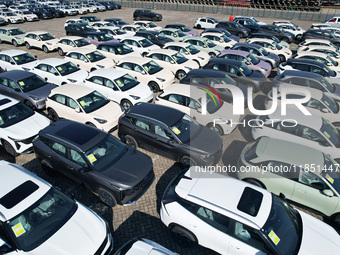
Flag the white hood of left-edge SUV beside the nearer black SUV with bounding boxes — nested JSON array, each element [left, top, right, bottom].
[[2, 113, 50, 139]]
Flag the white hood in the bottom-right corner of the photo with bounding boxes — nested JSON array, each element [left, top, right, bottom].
[[298, 211, 340, 255]]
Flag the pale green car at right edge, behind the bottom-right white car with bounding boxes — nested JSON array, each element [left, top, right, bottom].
[[237, 137, 340, 226]]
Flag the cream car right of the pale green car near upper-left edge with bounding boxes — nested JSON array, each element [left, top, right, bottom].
[[25, 31, 59, 53]]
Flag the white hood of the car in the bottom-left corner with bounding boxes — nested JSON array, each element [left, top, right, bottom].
[[29, 204, 106, 255]]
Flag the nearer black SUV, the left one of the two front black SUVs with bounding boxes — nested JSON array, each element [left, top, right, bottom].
[[33, 119, 155, 207]]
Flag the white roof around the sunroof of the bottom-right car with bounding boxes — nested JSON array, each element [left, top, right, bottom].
[[175, 167, 272, 229]]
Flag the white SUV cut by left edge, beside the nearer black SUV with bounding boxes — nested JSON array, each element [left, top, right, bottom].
[[0, 95, 50, 157]]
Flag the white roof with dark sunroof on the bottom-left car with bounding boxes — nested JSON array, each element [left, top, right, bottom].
[[0, 160, 51, 221]]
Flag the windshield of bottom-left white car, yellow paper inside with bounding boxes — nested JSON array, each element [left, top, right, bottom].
[[7, 188, 78, 251]]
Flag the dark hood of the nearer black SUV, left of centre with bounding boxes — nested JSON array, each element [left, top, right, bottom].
[[98, 147, 153, 188]]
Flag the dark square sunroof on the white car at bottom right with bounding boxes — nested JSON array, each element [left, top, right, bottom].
[[237, 187, 263, 217]]
